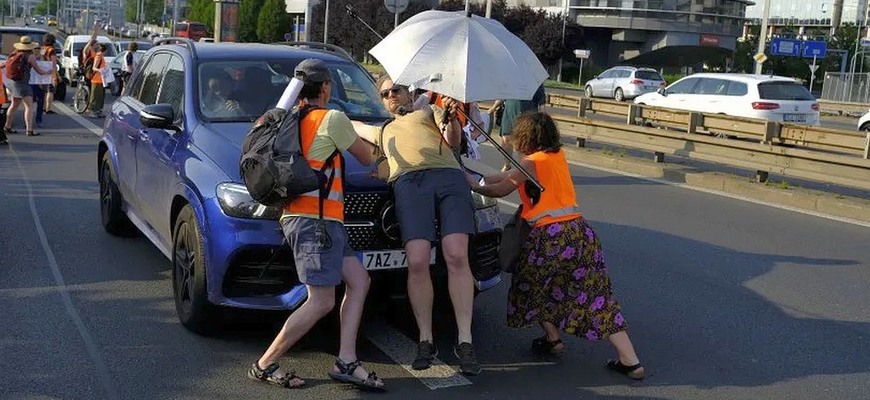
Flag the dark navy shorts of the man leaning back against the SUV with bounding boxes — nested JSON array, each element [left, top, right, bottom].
[[393, 168, 475, 243]]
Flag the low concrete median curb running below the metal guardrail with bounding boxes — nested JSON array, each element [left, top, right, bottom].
[[562, 145, 870, 224]]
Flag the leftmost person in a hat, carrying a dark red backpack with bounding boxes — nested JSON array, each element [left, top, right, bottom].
[[3, 36, 51, 136]]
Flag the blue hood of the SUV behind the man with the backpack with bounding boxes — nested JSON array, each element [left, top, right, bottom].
[[199, 122, 387, 190]]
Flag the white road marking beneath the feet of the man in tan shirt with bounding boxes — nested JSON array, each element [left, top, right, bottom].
[[365, 325, 471, 390]]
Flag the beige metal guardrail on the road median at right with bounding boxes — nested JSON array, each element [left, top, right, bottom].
[[548, 95, 870, 190]]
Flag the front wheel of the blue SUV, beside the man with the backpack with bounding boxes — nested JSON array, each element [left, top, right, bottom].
[[172, 204, 218, 335]]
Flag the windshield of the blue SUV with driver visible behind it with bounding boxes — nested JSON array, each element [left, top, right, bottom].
[[198, 59, 390, 122]]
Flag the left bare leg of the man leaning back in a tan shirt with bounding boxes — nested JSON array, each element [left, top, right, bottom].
[[405, 239, 435, 343]]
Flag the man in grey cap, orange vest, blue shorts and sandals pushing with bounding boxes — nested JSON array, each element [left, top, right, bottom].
[[248, 59, 384, 391]]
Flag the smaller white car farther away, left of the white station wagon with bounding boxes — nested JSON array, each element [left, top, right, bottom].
[[585, 67, 666, 101]]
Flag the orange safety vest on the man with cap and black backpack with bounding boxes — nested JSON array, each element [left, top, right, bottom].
[[284, 108, 344, 222]]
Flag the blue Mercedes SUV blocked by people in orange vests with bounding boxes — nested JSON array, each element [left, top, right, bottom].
[[96, 38, 501, 333]]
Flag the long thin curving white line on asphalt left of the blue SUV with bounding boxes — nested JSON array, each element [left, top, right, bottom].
[[9, 148, 121, 400]]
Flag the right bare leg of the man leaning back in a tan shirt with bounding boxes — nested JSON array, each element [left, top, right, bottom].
[[441, 233, 474, 343]]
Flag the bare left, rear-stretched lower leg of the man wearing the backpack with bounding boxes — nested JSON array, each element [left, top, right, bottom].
[[258, 285, 335, 368]]
